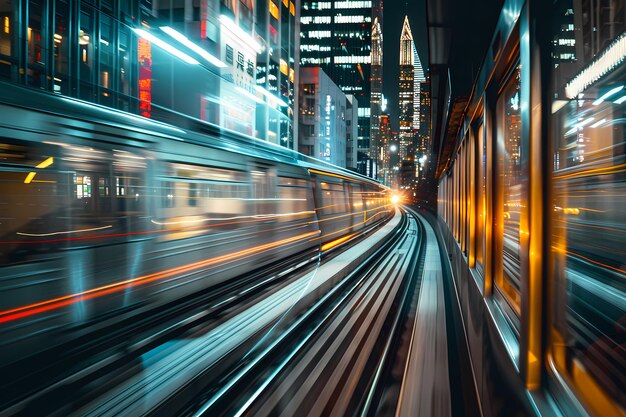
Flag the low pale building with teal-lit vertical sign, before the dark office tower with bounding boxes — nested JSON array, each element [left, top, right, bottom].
[[298, 67, 346, 168]]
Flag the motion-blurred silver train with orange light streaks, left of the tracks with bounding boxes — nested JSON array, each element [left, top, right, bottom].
[[0, 83, 394, 365]]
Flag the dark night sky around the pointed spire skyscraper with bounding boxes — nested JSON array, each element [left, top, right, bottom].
[[383, 0, 428, 130]]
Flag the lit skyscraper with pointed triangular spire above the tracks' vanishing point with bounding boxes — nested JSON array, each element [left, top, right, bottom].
[[398, 16, 425, 159]]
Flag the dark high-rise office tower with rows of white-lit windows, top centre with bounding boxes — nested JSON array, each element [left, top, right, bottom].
[[300, 0, 382, 174]]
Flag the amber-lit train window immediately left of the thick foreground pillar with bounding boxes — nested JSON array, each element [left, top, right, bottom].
[[495, 65, 527, 322]]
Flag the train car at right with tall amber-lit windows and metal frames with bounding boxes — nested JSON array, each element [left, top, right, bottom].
[[438, 1, 626, 416]]
